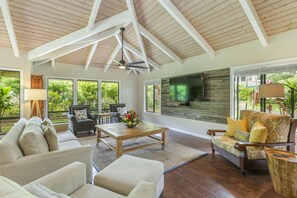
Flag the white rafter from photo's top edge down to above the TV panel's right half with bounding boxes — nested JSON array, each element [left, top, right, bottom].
[[158, 0, 215, 58]]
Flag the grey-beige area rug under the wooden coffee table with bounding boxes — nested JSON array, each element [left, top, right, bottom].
[[79, 136, 207, 173]]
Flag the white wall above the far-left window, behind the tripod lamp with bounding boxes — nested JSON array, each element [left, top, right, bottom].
[[0, 48, 31, 118]]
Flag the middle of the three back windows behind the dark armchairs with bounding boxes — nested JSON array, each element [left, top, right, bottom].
[[77, 80, 98, 113]]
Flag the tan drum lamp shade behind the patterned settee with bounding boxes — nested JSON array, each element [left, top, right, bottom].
[[259, 83, 285, 98]]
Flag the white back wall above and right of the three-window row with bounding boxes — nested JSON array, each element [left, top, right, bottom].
[[32, 63, 138, 111]]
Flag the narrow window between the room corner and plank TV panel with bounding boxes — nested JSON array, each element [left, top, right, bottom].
[[145, 81, 161, 113]]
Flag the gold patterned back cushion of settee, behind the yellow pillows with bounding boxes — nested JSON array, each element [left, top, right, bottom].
[[240, 110, 290, 143]]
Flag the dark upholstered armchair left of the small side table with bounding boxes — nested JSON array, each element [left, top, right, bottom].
[[69, 105, 96, 135]]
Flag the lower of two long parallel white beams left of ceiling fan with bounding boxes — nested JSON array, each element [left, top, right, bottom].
[[32, 27, 119, 65]]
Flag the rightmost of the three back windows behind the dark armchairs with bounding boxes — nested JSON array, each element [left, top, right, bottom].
[[101, 81, 120, 112]]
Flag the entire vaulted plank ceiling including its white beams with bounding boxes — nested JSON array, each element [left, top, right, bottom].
[[0, 0, 297, 74]]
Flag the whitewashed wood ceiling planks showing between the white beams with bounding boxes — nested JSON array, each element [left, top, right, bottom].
[[0, 0, 297, 72]]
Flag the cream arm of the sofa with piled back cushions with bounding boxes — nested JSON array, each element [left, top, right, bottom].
[[0, 145, 93, 185]]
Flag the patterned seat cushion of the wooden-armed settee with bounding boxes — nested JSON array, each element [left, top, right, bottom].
[[211, 135, 266, 159]]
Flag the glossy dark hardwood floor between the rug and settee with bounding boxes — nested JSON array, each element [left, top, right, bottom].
[[163, 131, 282, 198]]
